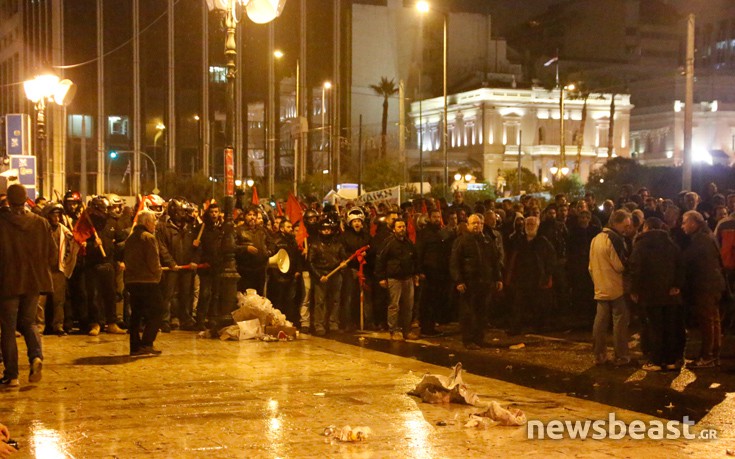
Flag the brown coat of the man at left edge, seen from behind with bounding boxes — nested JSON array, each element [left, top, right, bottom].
[[0, 210, 58, 298]]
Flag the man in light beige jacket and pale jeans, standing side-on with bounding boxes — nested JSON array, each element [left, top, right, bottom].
[[589, 210, 631, 365]]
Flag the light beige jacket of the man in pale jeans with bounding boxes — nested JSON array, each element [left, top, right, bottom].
[[588, 228, 625, 301]]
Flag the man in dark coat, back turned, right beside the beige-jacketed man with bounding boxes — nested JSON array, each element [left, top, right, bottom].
[[627, 217, 685, 371]]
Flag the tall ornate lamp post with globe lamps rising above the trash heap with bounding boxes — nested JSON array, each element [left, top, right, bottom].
[[207, 0, 286, 336]]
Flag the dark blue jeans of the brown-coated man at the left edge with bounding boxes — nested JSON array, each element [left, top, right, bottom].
[[0, 295, 43, 379]]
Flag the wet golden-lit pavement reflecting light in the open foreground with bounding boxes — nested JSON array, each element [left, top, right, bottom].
[[0, 332, 735, 458]]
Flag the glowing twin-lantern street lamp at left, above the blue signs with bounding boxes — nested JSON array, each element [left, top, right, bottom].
[[23, 73, 76, 199]]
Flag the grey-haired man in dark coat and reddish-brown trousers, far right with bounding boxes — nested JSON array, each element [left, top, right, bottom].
[[681, 210, 725, 368]]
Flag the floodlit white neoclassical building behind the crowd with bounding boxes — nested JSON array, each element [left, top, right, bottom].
[[409, 87, 633, 190]]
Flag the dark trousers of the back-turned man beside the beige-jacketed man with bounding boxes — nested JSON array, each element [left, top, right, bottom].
[[641, 304, 685, 365]]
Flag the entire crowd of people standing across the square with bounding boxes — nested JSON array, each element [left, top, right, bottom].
[[0, 184, 735, 386]]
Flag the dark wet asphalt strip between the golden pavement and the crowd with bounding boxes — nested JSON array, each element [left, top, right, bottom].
[[330, 323, 735, 421]]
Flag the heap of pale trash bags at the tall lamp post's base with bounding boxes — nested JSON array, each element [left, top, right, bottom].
[[219, 289, 295, 341]]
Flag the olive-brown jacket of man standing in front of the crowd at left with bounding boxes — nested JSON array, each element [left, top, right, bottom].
[[123, 225, 163, 284]]
